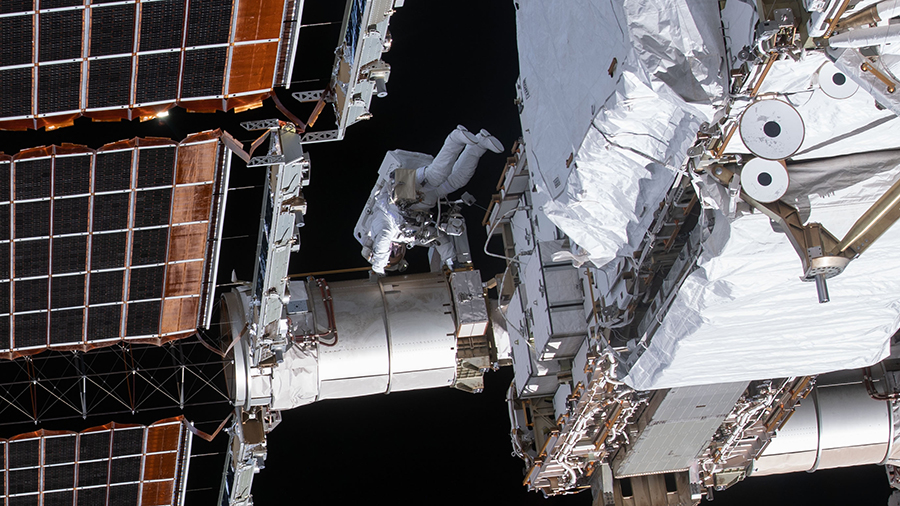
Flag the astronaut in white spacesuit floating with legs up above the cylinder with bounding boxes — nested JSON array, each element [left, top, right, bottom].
[[363, 125, 503, 275]]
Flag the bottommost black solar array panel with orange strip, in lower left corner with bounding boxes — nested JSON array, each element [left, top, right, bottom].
[[0, 417, 191, 506]]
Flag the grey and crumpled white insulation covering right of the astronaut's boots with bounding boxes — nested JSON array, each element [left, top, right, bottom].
[[517, 0, 724, 266]]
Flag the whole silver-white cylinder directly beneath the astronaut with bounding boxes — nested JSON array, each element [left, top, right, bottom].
[[222, 273, 457, 409]]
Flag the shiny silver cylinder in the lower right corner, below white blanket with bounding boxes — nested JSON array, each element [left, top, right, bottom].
[[752, 371, 893, 476]]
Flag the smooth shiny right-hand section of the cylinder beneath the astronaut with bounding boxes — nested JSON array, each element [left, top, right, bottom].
[[318, 273, 456, 400]]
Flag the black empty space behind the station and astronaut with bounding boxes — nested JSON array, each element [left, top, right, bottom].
[[0, 0, 890, 506]]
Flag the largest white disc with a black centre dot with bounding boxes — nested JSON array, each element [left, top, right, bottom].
[[739, 100, 805, 160]]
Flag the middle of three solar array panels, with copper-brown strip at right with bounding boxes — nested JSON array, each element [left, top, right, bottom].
[[0, 132, 228, 358]]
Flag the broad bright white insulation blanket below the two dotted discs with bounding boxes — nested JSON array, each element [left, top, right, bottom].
[[626, 156, 900, 390]]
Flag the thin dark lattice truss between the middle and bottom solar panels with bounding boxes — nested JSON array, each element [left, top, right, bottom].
[[0, 334, 231, 427]]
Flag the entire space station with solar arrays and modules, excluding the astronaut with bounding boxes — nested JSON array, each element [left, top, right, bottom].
[[8, 0, 900, 506]]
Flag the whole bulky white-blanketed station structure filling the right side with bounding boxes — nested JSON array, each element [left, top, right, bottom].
[[483, 0, 900, 506]]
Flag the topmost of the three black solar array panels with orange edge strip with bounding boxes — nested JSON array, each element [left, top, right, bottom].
[[0, 0, 302, 129]]
